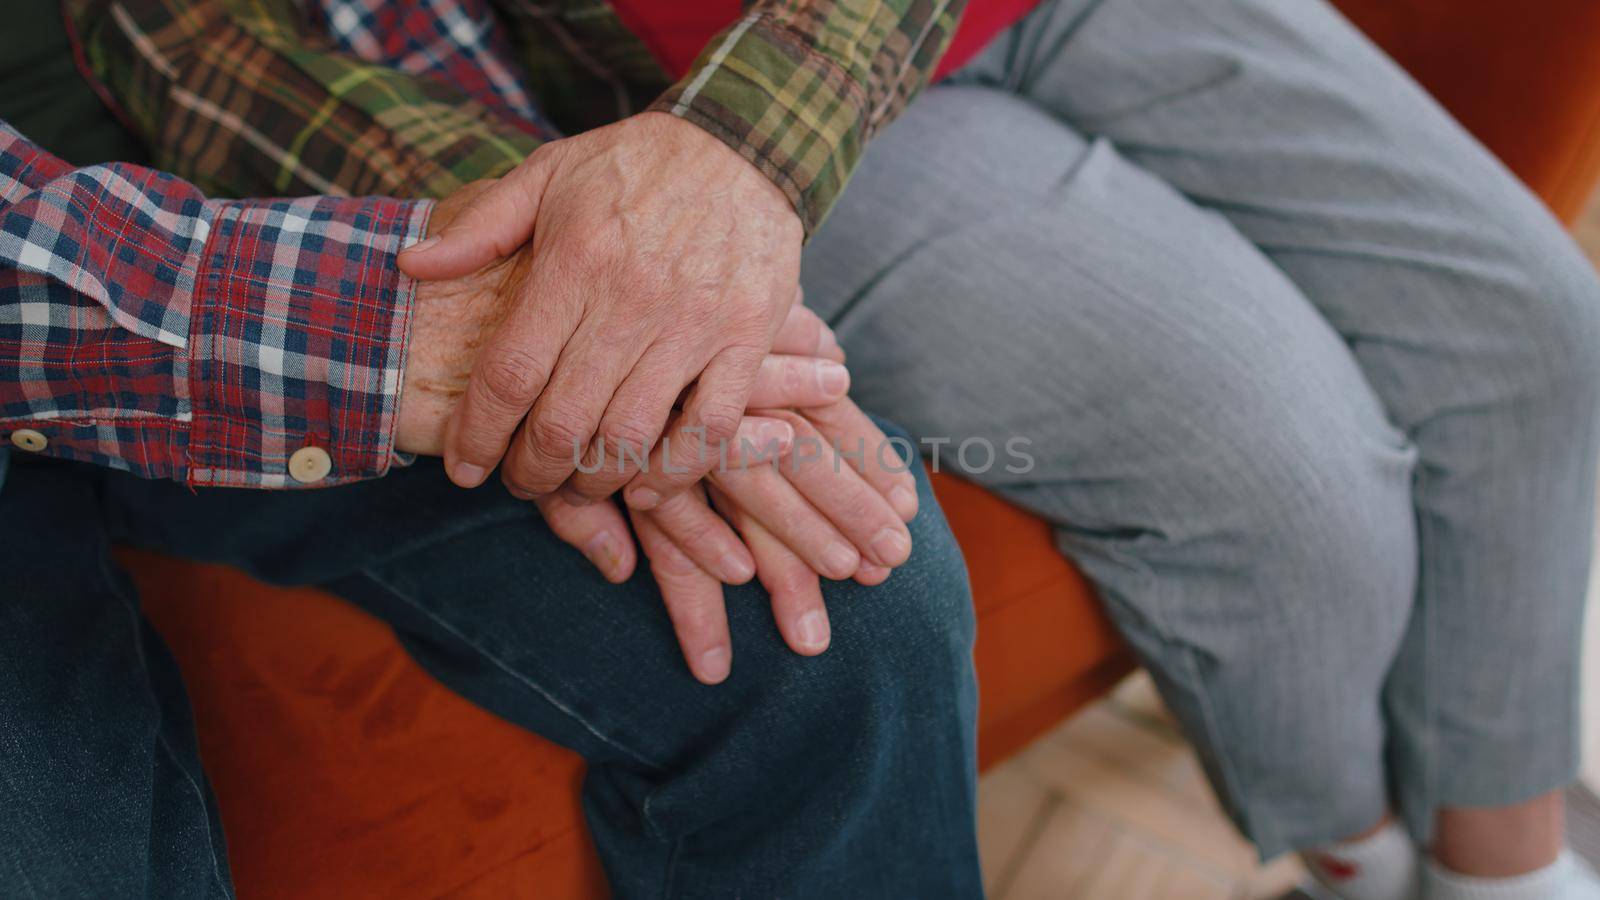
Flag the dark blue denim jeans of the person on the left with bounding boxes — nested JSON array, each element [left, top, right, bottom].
[[0, 422, 982, 898]]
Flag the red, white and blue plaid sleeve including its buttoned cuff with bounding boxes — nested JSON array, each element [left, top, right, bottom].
[[0, 122, 432, 488]]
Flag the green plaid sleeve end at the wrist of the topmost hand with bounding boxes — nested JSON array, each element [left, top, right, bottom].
[[651, 0, 965, 234]]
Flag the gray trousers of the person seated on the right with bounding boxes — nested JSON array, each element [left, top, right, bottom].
[[803, 0, 1600, 857]]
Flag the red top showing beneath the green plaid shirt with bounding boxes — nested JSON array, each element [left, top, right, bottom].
[[611, 0, 1040, 80]]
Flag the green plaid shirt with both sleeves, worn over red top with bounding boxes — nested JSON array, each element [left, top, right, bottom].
[[64, 0, 965, 234]]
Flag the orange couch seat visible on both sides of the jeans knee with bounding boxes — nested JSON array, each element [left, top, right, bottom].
[[122, 476, 1133, 900]]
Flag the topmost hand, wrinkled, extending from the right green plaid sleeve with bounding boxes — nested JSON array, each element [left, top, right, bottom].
[[400, 112, 803, 496]]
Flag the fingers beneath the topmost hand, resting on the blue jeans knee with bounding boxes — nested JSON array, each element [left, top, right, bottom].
[[539, 384, 917, 684]]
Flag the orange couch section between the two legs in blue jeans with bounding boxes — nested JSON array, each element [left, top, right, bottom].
[[123, 552, 605, 900]]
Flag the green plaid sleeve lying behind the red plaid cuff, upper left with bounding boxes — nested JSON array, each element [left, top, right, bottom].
[[64, 0, 555, 197]]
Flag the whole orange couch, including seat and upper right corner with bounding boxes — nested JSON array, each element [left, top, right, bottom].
[[125, 0, 1600, 900]]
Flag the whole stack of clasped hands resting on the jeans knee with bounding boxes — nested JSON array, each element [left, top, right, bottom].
[[395, 112, 917, 684]]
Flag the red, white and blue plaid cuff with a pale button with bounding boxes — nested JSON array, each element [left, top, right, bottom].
[[187, 190, 432, 488]]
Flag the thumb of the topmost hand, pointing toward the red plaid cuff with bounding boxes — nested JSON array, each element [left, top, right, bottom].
[[398, 154, 550, 282]]
